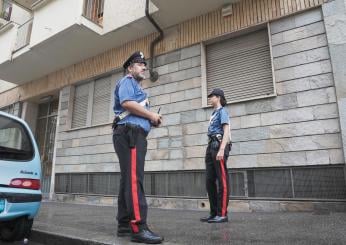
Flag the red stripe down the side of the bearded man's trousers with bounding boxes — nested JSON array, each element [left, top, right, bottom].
[[131, 147, 141, 232]]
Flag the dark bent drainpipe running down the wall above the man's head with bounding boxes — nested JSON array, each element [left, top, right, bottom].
[[145, 0, 163, 82]]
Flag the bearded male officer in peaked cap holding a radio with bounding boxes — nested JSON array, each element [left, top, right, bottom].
[[113, 52, 163, 244]]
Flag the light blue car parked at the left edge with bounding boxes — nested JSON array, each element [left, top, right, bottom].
[[0, 111, 42, 243]]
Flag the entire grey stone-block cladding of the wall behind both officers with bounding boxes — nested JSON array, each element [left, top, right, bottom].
[[56, 9, 344, 173]]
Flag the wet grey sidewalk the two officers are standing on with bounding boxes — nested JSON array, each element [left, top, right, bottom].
[[32, 202, 346, 245]]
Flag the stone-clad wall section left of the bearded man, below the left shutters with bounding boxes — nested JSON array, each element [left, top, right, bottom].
[[55, 86, 116, 173]]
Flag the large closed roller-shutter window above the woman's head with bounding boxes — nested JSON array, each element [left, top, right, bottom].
[[206, 29, 274, 102]]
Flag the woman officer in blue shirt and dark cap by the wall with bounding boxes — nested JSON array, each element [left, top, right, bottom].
[[201, 89, 231, 223]]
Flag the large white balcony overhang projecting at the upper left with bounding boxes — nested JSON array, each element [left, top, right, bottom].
[[0, 0, 162, 84]]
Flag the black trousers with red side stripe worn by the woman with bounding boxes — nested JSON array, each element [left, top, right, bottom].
[[205, 141, 230, 216]]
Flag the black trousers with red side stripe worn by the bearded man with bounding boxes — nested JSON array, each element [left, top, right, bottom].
[[113, 124, 148, 233]]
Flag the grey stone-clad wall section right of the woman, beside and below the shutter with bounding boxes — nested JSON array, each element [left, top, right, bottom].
[[226, 9, 344, 168]]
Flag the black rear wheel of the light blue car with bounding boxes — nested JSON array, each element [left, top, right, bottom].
[[0, 217, 34, 242]]
